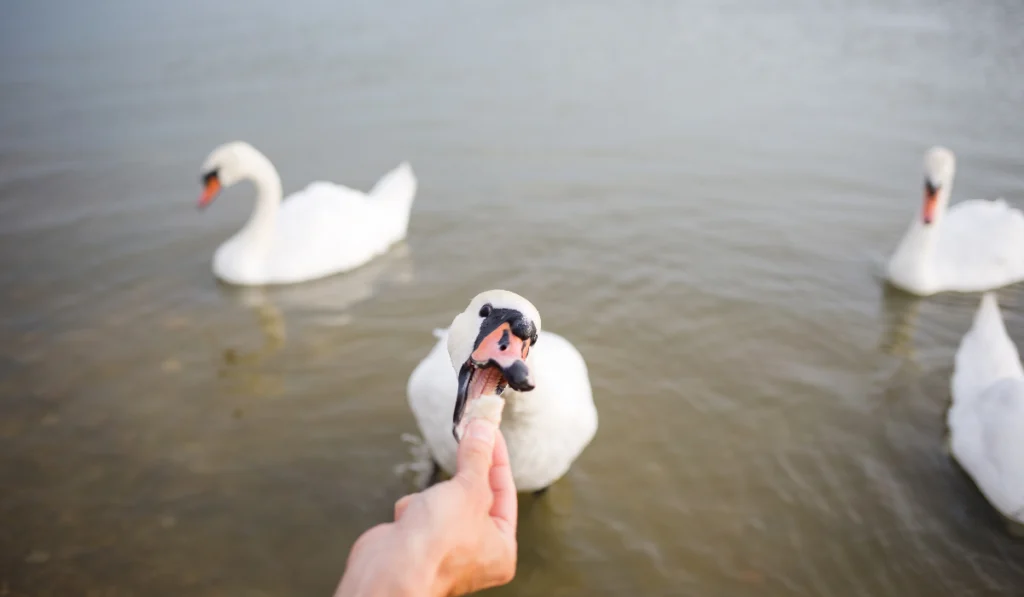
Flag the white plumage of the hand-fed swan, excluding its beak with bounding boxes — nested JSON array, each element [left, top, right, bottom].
[[407, 291, 598, 492]]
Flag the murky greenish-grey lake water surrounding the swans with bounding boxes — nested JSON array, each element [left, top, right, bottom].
[[0, 0, 1024, 597]]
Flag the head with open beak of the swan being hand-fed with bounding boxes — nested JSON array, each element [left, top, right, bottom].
[[447, 290, 541, 440]]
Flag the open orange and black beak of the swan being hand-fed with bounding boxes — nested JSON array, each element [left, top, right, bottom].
[[452, 315, 536, 441]]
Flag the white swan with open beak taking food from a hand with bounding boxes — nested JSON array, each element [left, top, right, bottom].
[[407, 290, 597, 493]]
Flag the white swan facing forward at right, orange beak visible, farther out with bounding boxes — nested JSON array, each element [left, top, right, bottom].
[[887, 146, 1024, 296]]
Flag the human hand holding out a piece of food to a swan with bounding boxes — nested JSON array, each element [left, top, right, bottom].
[[335, 419, 518, 597]]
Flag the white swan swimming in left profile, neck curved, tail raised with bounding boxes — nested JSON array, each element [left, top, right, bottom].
[[199, 141, 417, 286]]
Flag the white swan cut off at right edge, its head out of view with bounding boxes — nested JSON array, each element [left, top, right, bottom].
[[946, 293, 1024, 523]]
